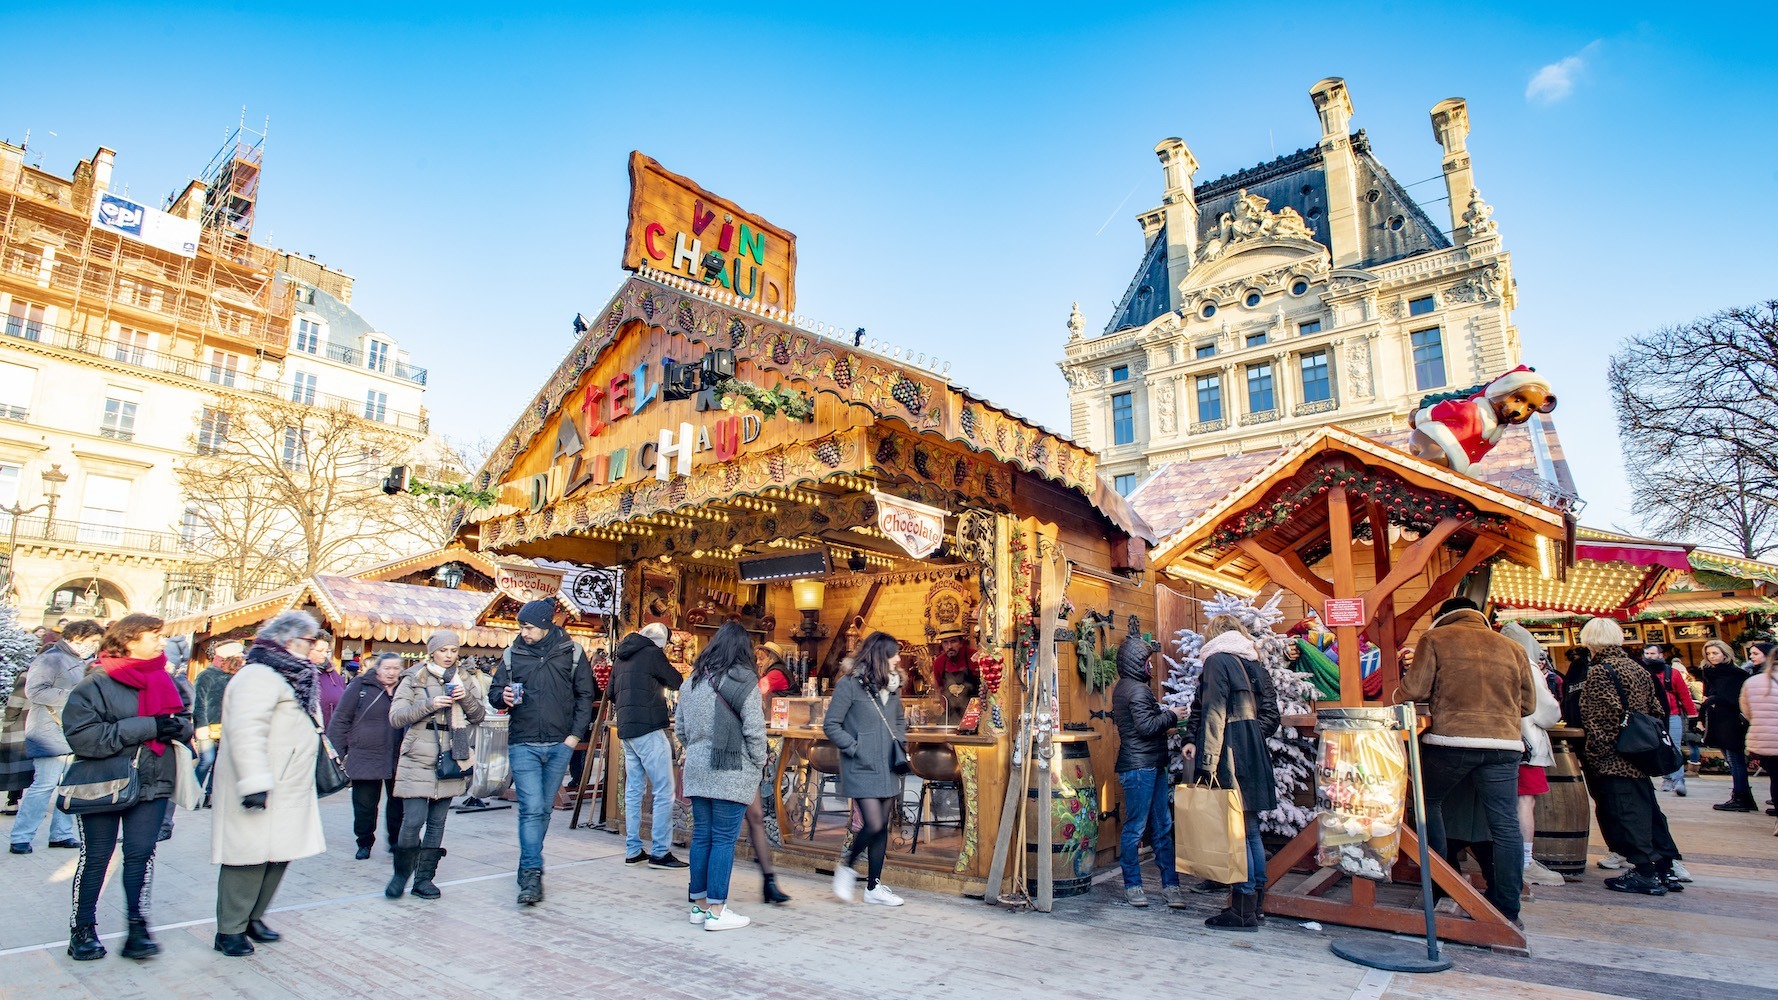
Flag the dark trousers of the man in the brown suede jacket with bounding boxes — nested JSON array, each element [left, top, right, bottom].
[[1421, 742, 1526, 920]]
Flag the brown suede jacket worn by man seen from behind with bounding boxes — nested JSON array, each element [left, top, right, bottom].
[[1401, 609, 1538, 751]]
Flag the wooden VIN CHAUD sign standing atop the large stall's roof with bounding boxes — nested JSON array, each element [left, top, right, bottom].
[[624, 153, 797, 310]]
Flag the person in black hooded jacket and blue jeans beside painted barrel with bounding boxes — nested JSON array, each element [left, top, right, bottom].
[[1111, 635, 1186, 909]]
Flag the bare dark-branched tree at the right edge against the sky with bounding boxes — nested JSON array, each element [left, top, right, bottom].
[[1609, 301, 1778, 559]]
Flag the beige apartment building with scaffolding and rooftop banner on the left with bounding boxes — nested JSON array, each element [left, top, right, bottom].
[[0, 133, 430, 625]]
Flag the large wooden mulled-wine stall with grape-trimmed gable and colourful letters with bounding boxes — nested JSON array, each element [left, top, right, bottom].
[[461, 269, 1154, 895]]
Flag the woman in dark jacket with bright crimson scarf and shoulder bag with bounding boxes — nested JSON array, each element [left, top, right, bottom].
[[62, 614, 192, 963]]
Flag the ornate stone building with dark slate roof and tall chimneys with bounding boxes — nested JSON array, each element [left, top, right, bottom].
[[1060, 78, 1536, 495]]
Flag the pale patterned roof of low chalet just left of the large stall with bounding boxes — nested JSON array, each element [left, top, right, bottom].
[[293, 575, 514, 648]]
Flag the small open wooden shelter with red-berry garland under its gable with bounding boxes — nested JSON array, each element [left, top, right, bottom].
[[1154, 427, 1574, 948]]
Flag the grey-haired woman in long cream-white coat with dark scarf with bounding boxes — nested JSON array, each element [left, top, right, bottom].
[[210, 610, 327, 957]]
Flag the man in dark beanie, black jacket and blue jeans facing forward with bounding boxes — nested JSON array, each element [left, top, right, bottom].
[[487, 598, 599, 906]]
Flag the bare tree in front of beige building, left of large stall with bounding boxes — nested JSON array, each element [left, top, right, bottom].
[[178, 397, 437, 600]]
